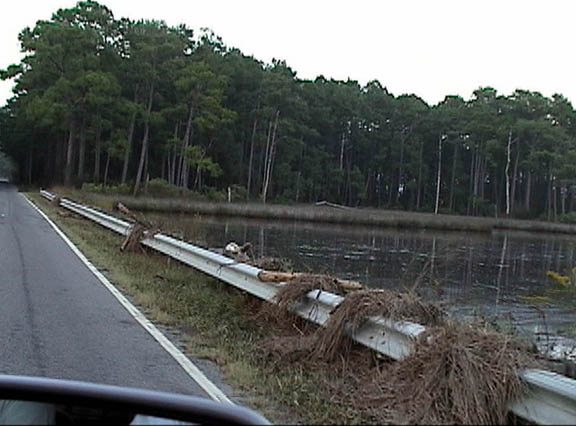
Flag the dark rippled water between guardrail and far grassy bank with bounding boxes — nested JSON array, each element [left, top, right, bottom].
[[150, 211, 576, 355]]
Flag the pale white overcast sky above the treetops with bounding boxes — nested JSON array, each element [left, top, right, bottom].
[[0, 0, 576, 105]]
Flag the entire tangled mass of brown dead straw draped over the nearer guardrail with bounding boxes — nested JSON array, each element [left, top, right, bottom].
[[263, 284, 536, 424]]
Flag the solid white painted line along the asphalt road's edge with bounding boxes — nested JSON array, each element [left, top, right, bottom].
[[23, 196, 233, 404]]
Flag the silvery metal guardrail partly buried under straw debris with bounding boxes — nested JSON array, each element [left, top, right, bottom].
[[40, 191, 576, 424]]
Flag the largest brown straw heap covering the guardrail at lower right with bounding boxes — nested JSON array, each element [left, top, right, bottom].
[[380, 323, 535, 424]]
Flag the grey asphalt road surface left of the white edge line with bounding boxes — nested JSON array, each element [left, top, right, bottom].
[[0, 184, 212, 397]]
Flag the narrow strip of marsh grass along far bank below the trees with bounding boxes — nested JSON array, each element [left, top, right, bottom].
[[47, 187, 576, 234]]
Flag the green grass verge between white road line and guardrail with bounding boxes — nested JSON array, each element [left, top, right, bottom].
[[27, 193, 369, 423]]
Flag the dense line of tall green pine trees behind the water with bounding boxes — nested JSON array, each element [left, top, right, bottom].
[[0, 1, 576, 220]]
